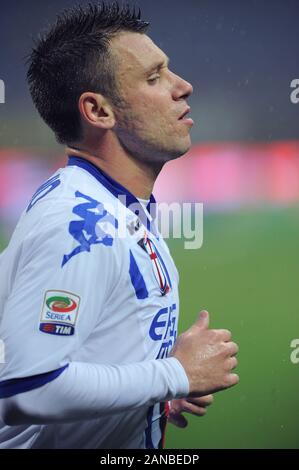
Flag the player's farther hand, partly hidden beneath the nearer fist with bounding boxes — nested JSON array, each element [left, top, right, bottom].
[[168, 395, 214, 428]]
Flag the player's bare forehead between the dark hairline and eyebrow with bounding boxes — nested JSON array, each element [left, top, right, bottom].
[[112, 32, 168, 73]]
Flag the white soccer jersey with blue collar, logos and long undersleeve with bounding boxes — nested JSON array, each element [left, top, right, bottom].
[[0, 156, 189, 448]]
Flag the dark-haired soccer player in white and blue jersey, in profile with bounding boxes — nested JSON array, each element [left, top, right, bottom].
[[0, 3, 238, 449]]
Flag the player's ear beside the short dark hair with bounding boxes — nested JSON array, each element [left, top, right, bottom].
[[79, 92, 115, 130]]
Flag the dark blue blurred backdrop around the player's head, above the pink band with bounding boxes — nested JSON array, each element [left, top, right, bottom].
[[0, 0, 299, 145]]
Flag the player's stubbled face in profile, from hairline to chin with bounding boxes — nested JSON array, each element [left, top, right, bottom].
[[112, 32, 193, 163]]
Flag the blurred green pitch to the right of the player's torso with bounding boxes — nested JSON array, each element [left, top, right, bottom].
[[0, 208, 299, 449]]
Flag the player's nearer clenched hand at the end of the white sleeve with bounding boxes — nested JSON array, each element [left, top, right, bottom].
[[170, 310, 239, 397]]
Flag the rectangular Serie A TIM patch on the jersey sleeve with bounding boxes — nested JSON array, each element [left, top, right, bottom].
[[39, 290, 80, 336]]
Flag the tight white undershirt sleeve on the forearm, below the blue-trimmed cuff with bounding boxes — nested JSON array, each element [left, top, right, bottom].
[[0, 357, 189, 426]]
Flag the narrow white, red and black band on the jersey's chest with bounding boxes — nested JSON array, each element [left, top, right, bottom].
[[138, 233, 171, 295]]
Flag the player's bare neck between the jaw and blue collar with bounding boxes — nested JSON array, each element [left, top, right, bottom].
[[66, 134, 162, 199]]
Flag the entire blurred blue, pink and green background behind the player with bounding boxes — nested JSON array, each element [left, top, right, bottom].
[[0, 0, 299, 449]]
